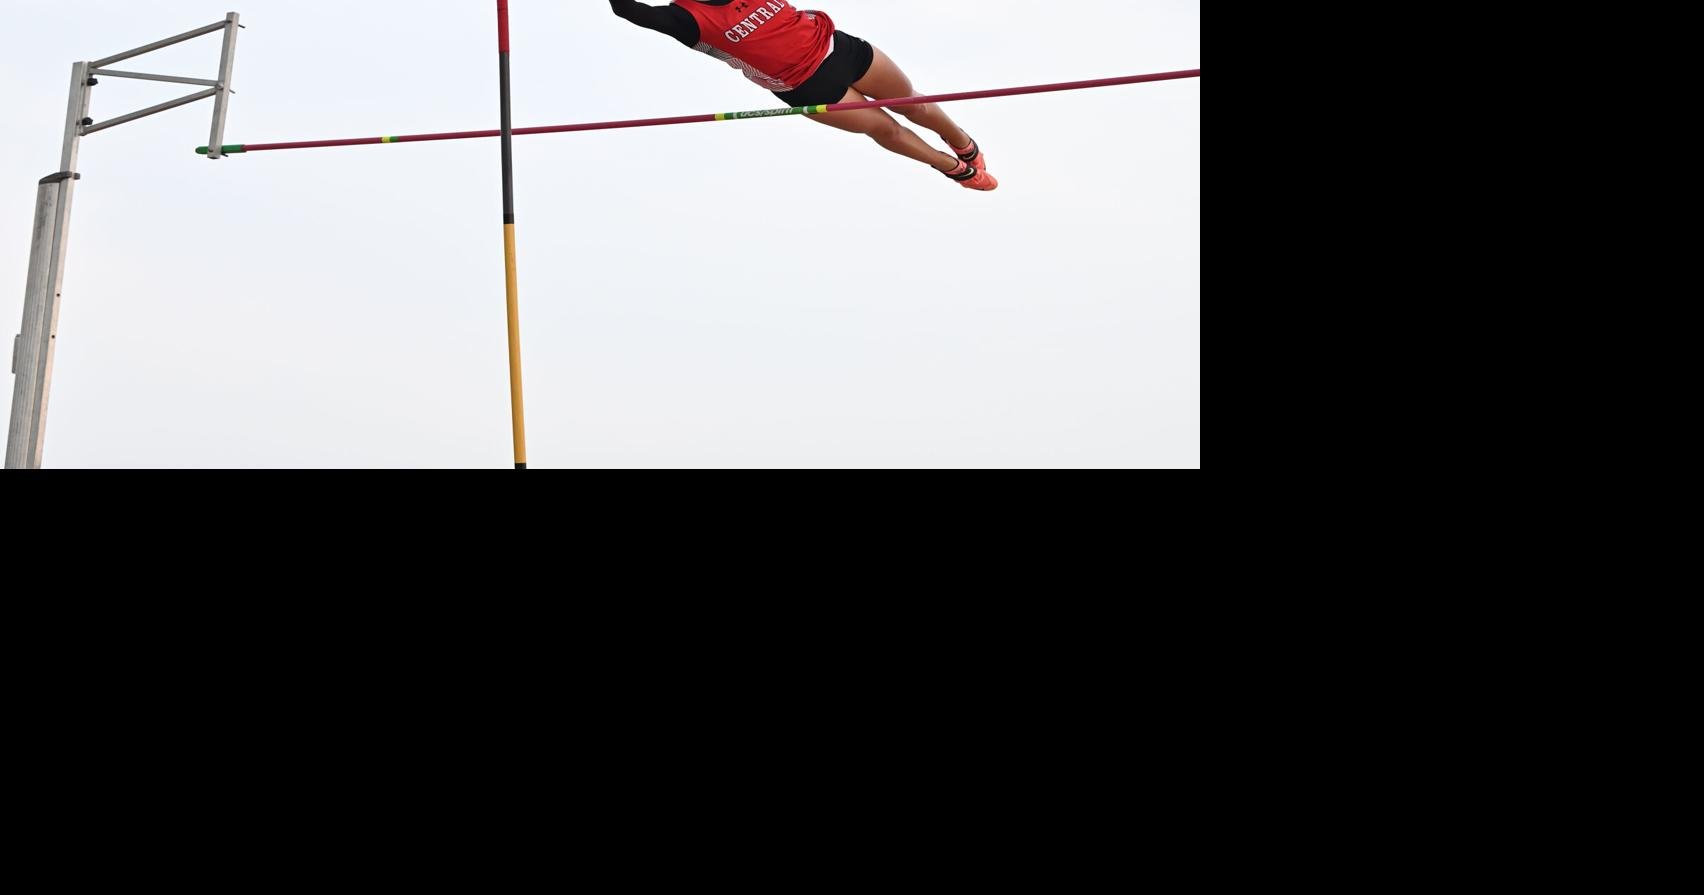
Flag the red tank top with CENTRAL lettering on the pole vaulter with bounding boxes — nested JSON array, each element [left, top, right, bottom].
[[675, 0, 835, 94]]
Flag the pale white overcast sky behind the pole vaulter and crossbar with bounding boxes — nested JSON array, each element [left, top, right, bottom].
[[0, 0, 1201, 469]]
